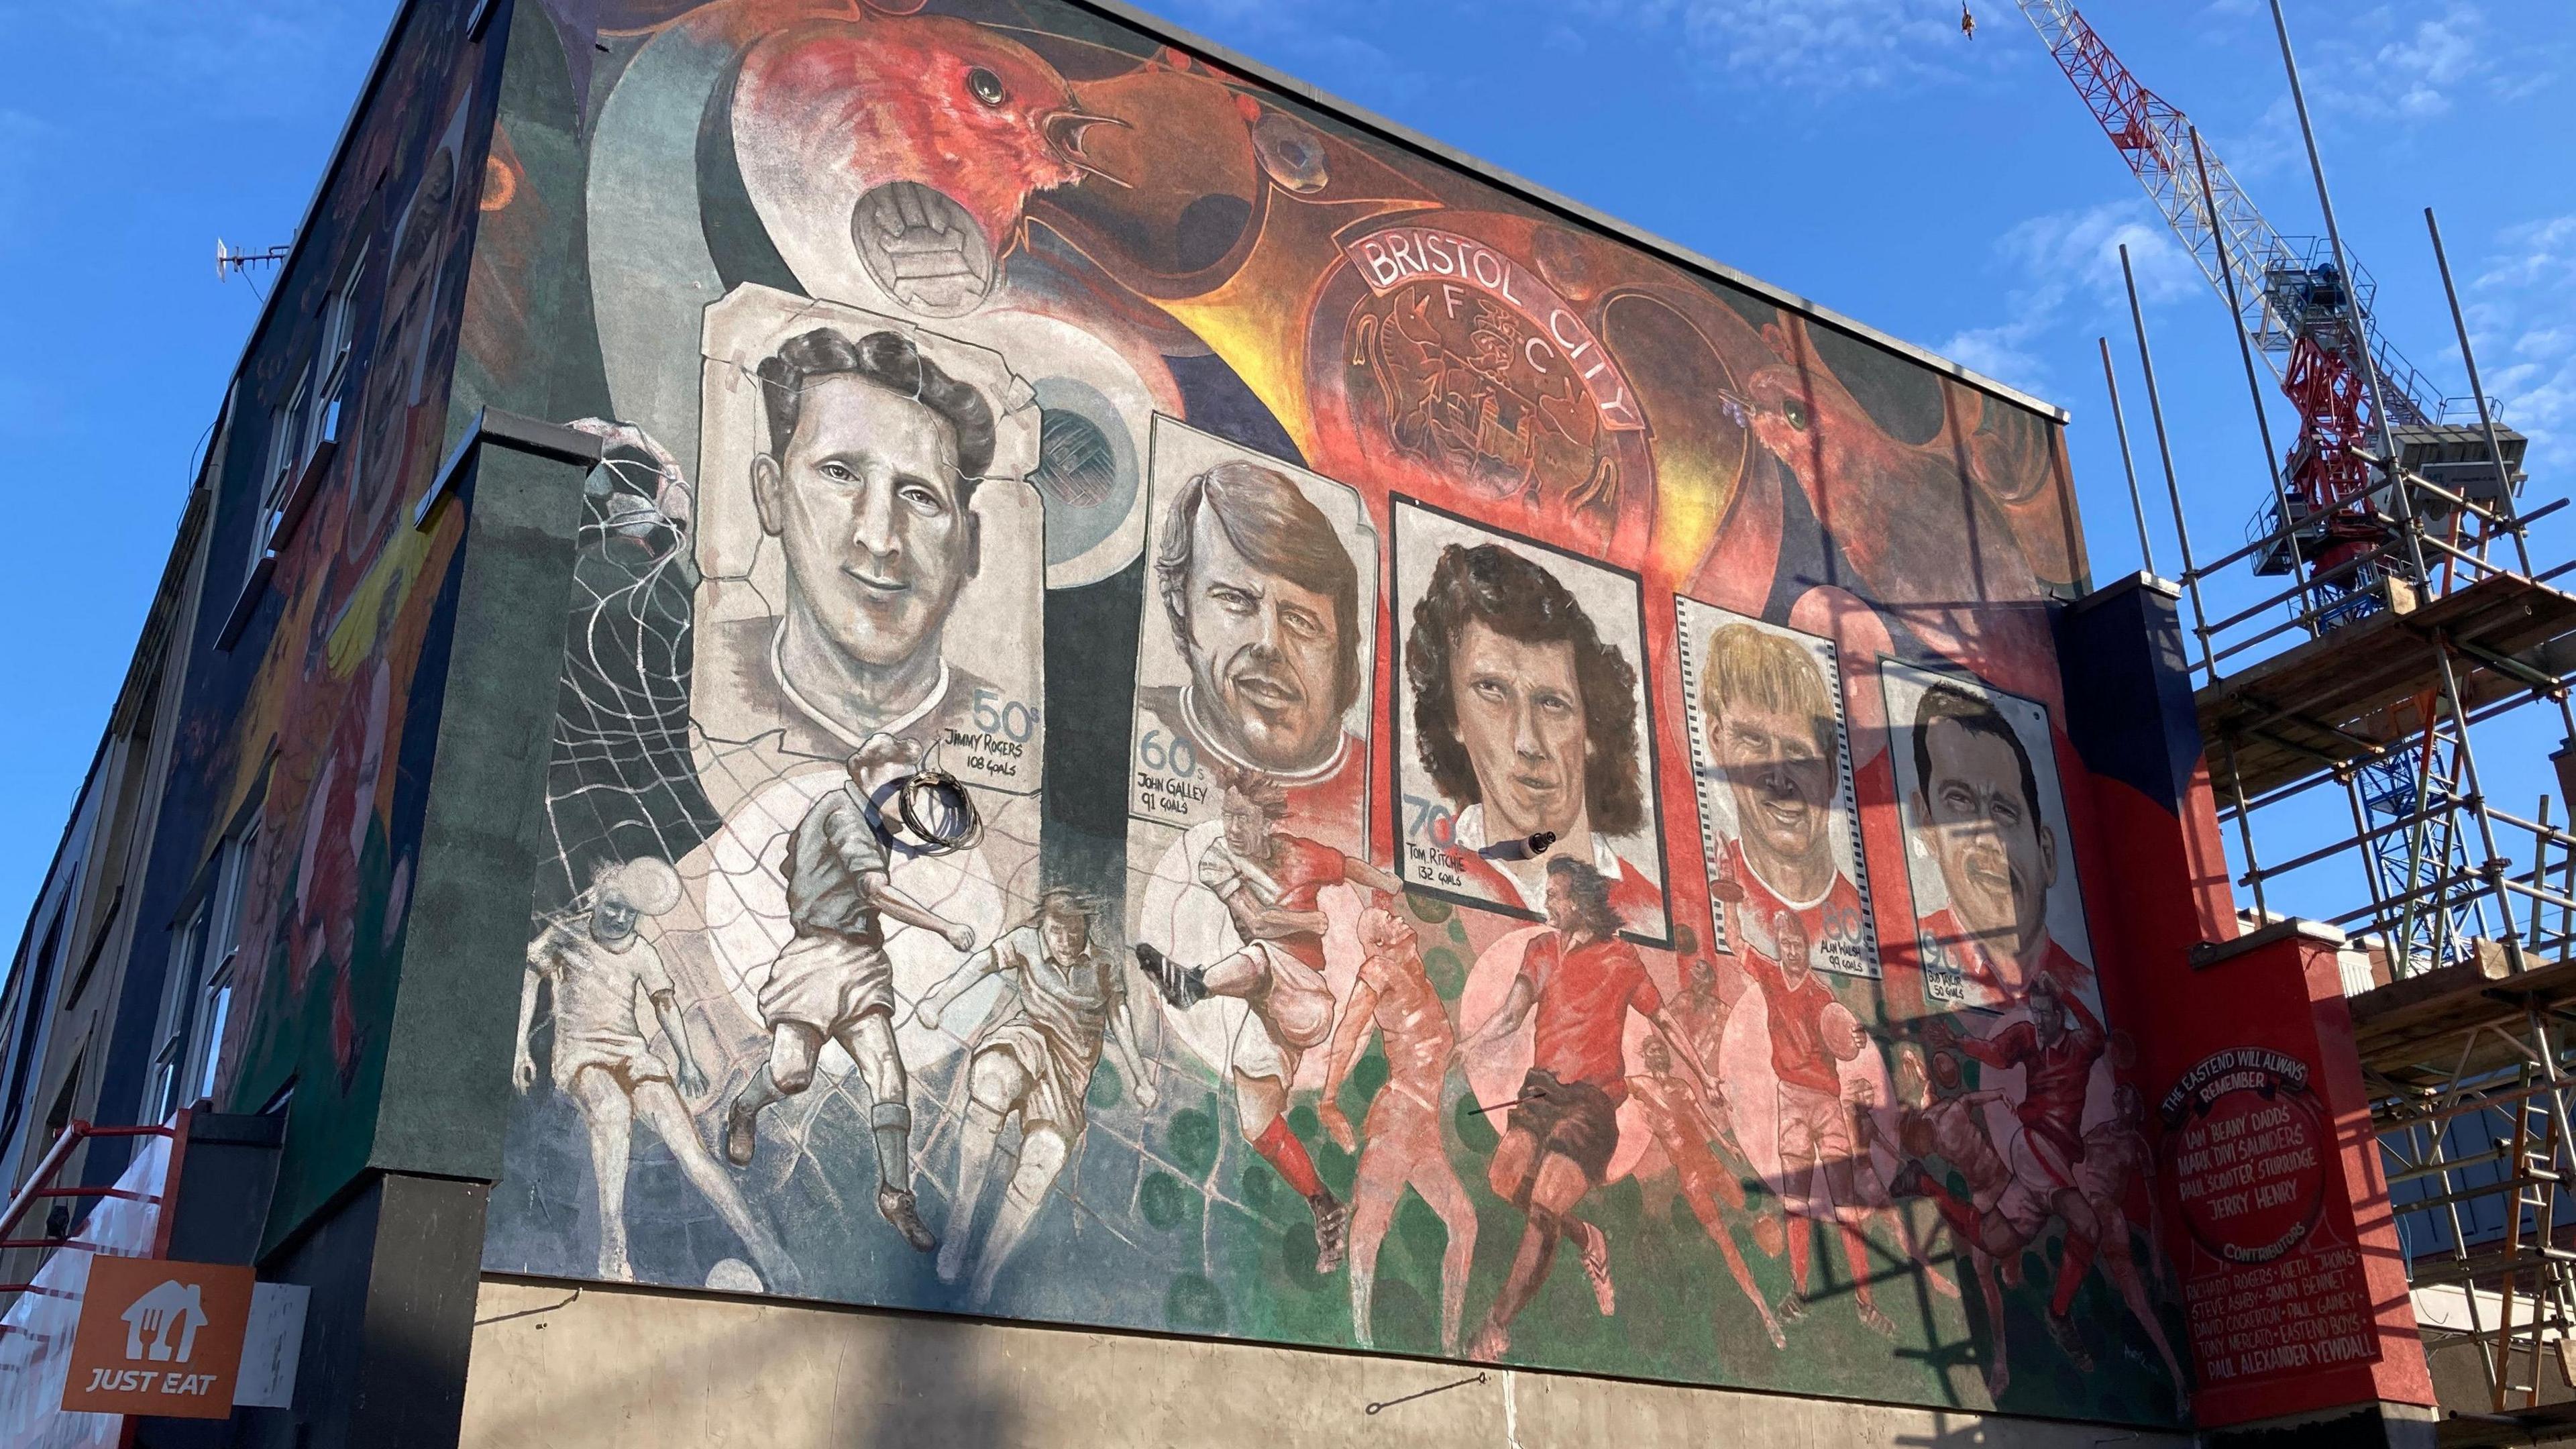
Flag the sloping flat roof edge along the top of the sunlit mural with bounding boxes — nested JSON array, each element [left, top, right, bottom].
[[1064, 0, 2074, 425]]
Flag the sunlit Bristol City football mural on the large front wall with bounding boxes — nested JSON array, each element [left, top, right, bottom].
[[464, 0, 2187, 1424]]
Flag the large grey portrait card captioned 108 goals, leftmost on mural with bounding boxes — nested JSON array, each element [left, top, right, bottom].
[[690, 286, 1046, 810]]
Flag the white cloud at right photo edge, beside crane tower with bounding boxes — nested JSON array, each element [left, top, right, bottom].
[[2468, 214, 2576, 474]]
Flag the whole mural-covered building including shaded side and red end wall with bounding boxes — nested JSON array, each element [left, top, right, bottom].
[[5, 0, 2429, 1446]]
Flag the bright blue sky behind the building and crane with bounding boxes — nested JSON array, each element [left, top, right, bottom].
[[0, 0, 2576, 936]]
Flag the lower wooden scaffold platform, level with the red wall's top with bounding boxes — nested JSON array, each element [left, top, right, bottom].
[[2347, 957, 2576, 1091]]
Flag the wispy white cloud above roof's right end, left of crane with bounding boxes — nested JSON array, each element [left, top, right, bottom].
[[1937, 201, 2202, 392]]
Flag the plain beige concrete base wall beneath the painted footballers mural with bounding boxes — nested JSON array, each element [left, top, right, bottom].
[[461, 1279, 2190, 1449]]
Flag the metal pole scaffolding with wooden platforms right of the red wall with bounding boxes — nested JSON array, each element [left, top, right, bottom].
[[2141, 242, 2576, 1413]]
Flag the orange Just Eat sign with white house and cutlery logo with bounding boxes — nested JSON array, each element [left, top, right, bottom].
[[62, 1256, 252, 1418]]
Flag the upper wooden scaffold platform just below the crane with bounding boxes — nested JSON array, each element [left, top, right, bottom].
[[2195, 572, 2576, 799]]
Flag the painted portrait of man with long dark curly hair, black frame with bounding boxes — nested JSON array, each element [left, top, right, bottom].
[[1396, 505, 1664, 938]]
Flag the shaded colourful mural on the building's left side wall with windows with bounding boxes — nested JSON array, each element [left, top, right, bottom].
[[172, 8, 490, 1222]]
